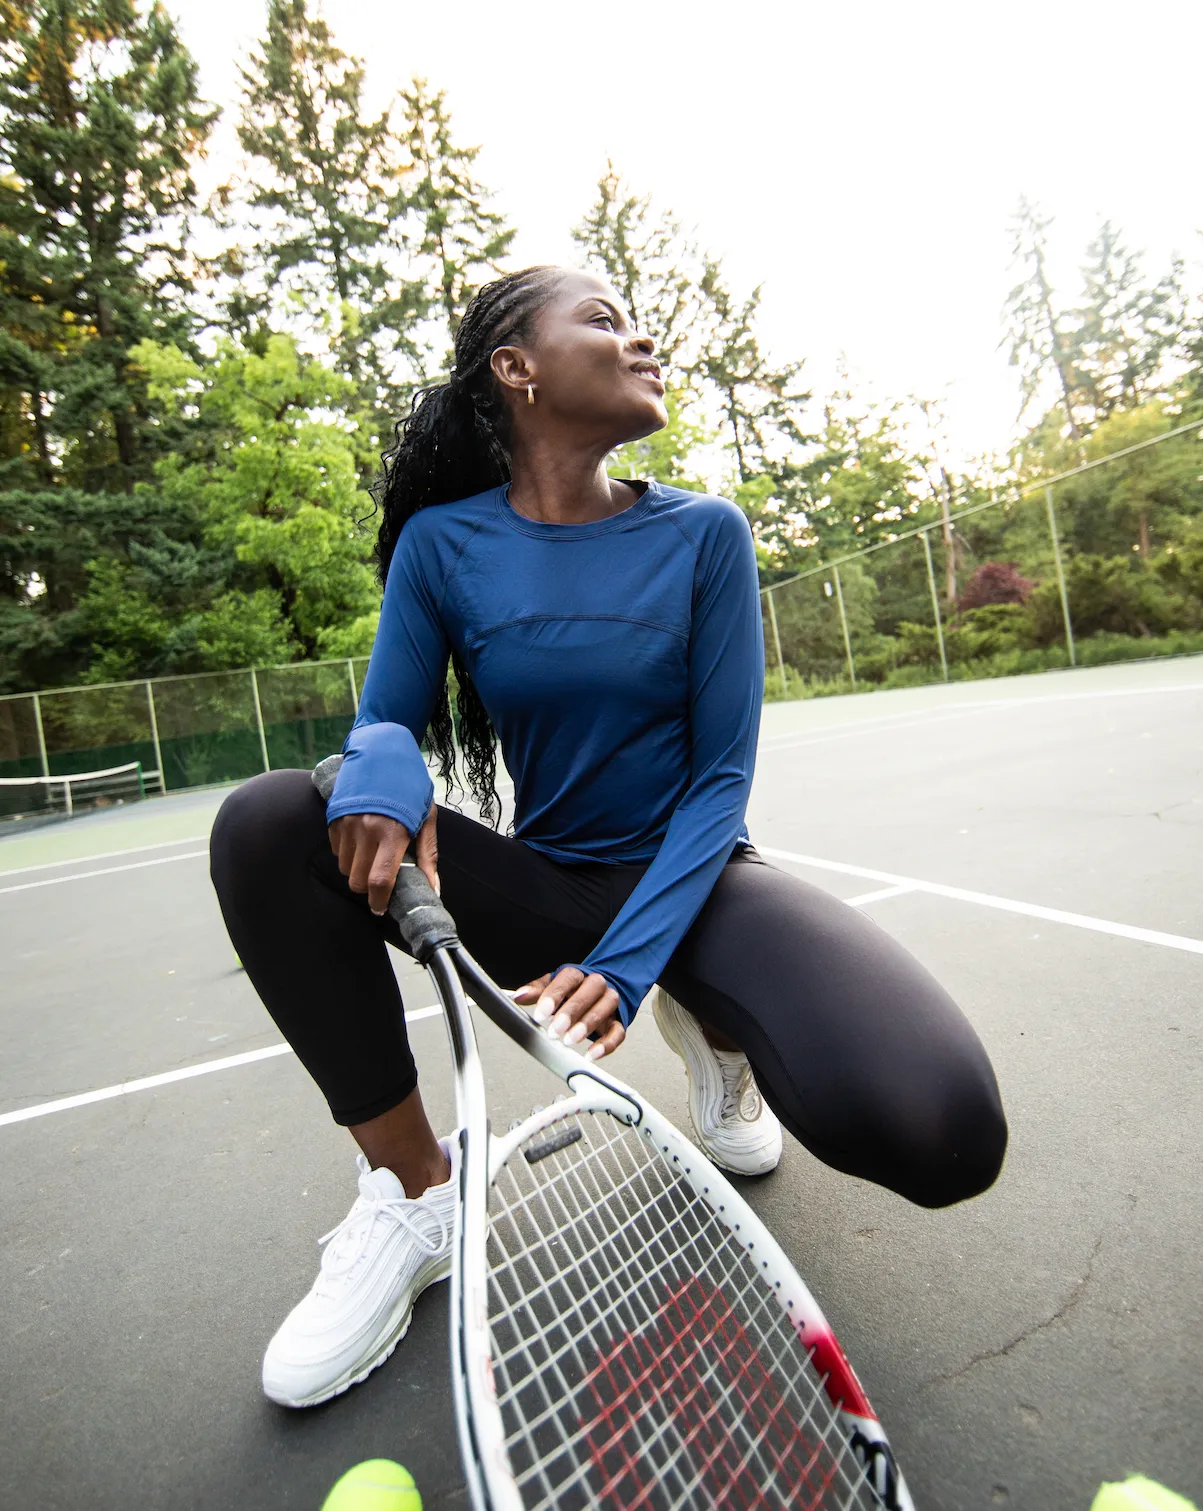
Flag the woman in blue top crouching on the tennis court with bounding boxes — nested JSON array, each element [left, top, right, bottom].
[[212, 267, 1007, 1407]]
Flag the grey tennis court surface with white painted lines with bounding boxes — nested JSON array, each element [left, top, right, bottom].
[[0, 657, 1203, 1511]]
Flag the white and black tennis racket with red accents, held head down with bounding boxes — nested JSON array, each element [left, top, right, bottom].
[[314, 756, 913, 1511]]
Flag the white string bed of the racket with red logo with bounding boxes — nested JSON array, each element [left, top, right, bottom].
[[488, 1114, 878, 1511]]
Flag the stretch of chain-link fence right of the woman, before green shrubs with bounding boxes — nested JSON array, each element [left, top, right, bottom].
[[762, 422, 1203, 698]]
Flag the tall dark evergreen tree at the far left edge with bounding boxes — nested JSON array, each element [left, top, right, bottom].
[[0, 0, 215, 691]]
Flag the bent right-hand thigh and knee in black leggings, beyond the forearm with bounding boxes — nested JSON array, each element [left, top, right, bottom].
[[662, 854, 1007, 1206]]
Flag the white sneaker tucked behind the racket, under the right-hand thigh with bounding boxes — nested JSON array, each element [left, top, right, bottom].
[[653, 987, 781, 1176]]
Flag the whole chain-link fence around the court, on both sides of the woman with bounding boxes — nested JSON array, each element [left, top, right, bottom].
[[0, 422, 1203, 792]]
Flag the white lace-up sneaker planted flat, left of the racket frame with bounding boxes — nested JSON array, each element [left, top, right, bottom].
[[263, 1136, 459, 1407]]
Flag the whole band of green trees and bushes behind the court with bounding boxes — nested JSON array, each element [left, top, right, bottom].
[[0, 0, 1203, 701]]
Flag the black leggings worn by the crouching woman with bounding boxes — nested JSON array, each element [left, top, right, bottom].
[[212, 771, 1007, 1207]]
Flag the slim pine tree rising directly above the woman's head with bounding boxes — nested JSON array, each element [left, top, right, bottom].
[[399, 79, 514, 347]]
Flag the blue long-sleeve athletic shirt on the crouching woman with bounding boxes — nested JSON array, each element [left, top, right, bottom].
[[326, 482, 765, 1024]]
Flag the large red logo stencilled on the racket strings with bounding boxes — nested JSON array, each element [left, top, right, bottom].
[[579, 1277, 855, 1511]]
